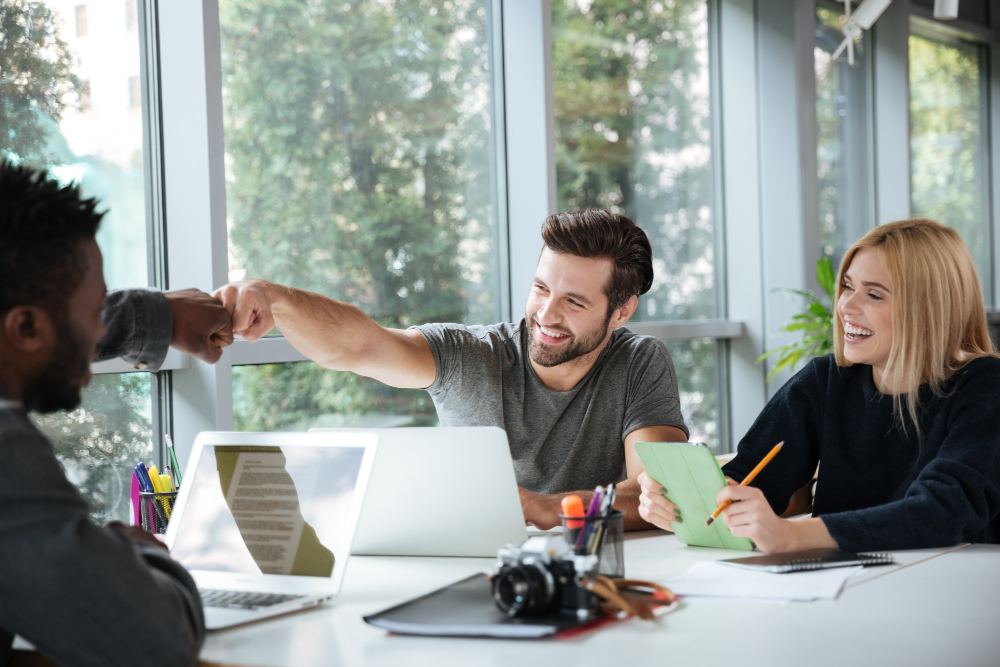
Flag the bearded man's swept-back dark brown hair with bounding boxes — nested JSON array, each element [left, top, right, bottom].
[[542, 208, 653, 317]]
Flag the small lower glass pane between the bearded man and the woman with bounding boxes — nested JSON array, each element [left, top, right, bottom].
[[663, 338, 722, 454]]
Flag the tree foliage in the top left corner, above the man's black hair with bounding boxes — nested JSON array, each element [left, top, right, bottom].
[[0, 0, 80, 166]]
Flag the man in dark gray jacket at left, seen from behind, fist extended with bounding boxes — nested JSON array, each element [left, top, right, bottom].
[[0, 160, 232, 667]]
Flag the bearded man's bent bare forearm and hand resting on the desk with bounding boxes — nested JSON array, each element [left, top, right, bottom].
[[520, 426, 688, 530]]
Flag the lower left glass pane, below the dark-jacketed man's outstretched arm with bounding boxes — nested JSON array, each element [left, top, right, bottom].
[[32, 376, 153, 523]]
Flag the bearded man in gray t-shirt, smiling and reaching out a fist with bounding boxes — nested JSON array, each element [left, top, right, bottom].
[[216, 209, 687, 529]]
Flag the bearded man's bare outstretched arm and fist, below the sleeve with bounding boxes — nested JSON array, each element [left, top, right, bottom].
[[215, 280, 437, 389]]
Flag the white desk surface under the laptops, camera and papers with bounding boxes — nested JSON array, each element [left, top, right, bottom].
[[202, 531, 1000, 667]]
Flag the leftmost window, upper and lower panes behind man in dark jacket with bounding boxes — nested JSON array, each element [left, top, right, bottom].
[[0, 0, 155, 521]]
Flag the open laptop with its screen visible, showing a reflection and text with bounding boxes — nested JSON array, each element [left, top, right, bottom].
[[165, 432, 378, 630]]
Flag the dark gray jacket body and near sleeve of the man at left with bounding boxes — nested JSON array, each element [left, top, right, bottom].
[[0, 409, 205, 667]]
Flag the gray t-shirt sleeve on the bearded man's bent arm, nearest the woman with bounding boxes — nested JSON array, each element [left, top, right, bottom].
[[622, 339, 690, 441]]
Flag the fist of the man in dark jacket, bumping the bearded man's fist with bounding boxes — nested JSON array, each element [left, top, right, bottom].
[[163, 289, 233, 364]]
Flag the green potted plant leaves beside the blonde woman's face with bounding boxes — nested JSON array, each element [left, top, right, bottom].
[[757, 257, 837, 382]]
